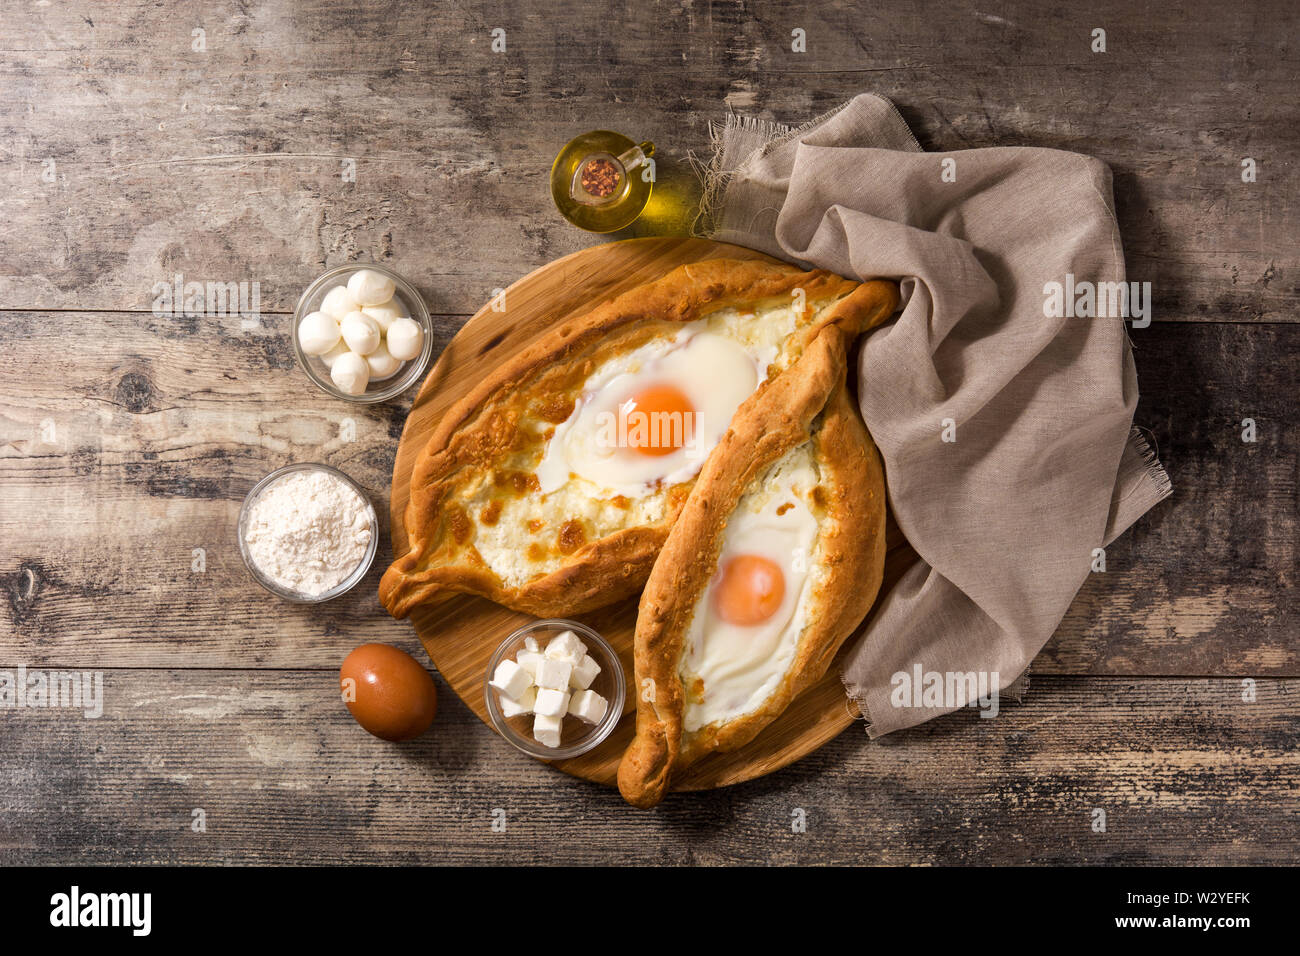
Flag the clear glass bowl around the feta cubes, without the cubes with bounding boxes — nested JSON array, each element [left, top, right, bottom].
[[484, 618, 627, 760]]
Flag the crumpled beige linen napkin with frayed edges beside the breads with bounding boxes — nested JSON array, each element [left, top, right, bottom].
[[701, 95, 1171, 736]]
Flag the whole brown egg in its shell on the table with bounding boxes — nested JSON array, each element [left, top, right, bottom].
[[338, 644, 438, 740]]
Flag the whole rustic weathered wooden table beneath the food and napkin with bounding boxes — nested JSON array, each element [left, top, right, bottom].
[[0, 0, 1300, 864]]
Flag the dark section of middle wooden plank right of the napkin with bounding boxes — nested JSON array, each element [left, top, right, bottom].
[[1035, 324, 1300, 675]]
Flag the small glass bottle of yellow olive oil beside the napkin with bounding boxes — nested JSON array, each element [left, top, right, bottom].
[[551, 130, 655, 233]]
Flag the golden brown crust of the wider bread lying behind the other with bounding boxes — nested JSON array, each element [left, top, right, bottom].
[[380, 259, 897, 618]]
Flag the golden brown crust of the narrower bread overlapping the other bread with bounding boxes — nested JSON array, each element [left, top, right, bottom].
[[619, 319, 885, 808]]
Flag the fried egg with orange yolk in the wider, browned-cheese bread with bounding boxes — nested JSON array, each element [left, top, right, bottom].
[[537, 323, 777, 497]]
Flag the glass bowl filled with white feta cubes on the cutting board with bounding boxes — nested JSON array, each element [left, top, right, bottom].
[[484, 618, 627, 760]]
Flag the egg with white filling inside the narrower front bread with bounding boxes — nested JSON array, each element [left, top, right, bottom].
[[679, 444, 819, 732]]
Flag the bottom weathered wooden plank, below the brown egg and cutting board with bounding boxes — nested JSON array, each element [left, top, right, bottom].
[[0, 670, 1300, 865]]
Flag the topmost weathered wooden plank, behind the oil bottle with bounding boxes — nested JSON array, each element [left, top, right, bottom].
[[0, 0, 1300, 321]]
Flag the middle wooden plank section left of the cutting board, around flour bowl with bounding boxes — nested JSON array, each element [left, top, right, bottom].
[[0, 312, 436, 667]]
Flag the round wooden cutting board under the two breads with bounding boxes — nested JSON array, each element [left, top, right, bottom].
[[391, 238, 909, 790]]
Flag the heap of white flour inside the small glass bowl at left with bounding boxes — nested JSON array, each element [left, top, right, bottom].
[[244, 471, 374, 596]]
